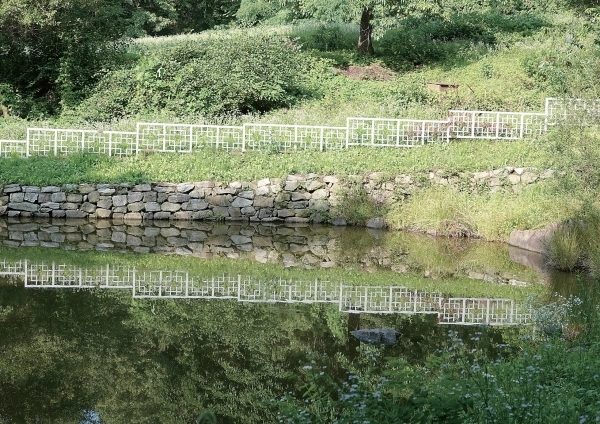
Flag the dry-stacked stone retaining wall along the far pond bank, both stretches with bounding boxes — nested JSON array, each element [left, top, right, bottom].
[[0, 167, 552, 225]]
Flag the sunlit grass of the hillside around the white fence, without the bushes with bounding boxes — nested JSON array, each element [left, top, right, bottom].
[[0, 11, 591, 240]]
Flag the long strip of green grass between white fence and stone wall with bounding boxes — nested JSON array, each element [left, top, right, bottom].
[[0, 140, 553, 185]]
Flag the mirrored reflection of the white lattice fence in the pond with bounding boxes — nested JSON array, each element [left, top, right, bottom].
[[0, 260, 531, 325]]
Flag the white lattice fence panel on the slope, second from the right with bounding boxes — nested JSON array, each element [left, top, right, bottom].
[[448, 110, 546, 140]]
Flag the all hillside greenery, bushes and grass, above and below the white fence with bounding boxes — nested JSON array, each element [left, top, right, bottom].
[[0, 0, 600, 250]]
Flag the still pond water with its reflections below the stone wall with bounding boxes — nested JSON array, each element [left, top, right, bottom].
[[0, 219, 570, 423]]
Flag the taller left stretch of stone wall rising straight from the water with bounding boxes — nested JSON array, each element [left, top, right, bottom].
[[0, 175, 338, 223]]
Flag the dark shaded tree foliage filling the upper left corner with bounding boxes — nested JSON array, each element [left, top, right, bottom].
[[0, 0, 129, 116]]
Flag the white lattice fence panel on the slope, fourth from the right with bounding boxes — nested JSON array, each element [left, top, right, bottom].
[[244, 124, 346, 153]]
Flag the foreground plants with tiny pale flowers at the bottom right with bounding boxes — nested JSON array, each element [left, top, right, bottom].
[[275, 282, 600, 423]]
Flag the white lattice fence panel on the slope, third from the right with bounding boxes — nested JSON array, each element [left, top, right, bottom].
[[346, 118, 448, 147]]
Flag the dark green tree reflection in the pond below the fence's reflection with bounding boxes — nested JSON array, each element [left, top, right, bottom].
[[0, 274, 524, 423]]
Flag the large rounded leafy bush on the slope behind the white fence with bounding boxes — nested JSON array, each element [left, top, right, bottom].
[[67, 36, 314, 120]]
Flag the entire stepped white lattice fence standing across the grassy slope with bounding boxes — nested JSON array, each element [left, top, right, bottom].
[[0, 98, 600, 158]]
